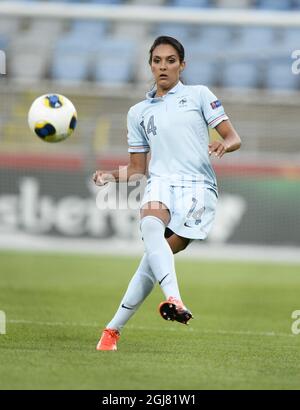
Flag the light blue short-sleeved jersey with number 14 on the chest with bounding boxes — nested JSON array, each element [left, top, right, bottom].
[[127, 82, 228, 191]]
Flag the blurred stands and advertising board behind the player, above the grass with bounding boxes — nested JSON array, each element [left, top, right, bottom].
[[0, 0, 300, 260]]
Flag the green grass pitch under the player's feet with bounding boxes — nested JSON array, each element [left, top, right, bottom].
[[0, 252, 300, 390]]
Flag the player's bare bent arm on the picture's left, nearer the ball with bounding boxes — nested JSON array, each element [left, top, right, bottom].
[[93, 152, 147, 186]]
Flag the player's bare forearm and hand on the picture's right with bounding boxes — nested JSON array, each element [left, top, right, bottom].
[[208, 120, 241, 158]]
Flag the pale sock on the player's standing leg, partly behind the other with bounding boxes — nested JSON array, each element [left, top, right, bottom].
[[106, 254, 156, 332]]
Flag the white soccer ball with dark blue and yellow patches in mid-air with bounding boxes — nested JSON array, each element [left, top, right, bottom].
[[28, 94, 77, 142]]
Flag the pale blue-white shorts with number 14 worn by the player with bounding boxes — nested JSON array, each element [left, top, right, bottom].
[[141, 177, 218, 240]]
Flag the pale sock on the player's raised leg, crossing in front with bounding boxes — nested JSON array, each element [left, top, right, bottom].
[[141, 215, 181, 300]]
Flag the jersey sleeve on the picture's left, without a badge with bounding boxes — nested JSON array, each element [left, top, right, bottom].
[[127, 109, 150, 153]]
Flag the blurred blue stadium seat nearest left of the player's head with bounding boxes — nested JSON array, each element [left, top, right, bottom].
[[94, 39, 136, 85]]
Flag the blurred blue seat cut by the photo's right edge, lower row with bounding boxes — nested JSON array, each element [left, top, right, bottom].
[[265, 56, 299, 91]]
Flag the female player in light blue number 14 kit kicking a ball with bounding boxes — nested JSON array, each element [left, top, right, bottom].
[[93, 36, 241, 350]]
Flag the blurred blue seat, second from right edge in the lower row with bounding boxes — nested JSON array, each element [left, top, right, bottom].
[[222, 59, 259, 88]]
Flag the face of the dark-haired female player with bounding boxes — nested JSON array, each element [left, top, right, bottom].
[[151, 44, 185, 92]]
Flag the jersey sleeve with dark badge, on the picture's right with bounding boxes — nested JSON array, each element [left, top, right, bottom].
[[201, 87, 228, 128]]
